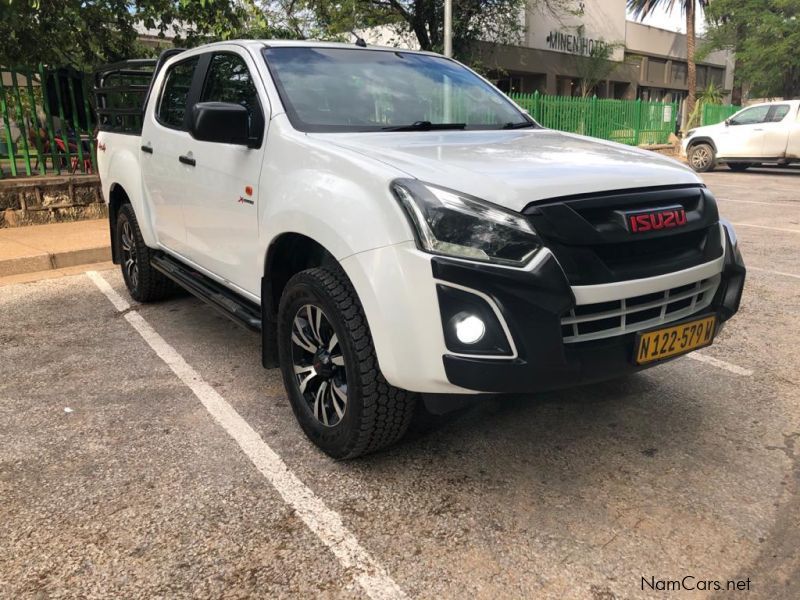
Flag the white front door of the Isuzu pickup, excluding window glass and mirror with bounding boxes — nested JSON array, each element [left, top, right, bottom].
[[181, 46, 269, 297]]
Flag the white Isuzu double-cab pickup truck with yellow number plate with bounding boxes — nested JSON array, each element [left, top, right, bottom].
[[96, 41, 745, 458]]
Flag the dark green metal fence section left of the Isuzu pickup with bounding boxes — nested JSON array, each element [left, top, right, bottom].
[[0, 65, 97, 178]]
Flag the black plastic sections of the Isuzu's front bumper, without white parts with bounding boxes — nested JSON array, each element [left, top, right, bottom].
[[433, 229, 745, 393]]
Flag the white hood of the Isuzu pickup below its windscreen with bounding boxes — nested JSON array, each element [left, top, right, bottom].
[[313, 129, 701, 211]]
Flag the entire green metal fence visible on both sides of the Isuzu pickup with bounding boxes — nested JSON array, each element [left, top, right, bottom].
[[0, 65, 740, 178]]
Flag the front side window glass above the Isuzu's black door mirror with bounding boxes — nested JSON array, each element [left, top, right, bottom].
[[200, 52, 264, 143]]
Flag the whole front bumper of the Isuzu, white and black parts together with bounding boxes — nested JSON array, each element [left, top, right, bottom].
[[341, 225, 745, 394]]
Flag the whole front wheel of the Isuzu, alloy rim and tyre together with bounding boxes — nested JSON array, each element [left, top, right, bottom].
[[278, 268, 417, 459]]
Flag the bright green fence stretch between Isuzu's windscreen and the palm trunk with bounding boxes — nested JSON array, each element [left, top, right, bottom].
[[511, 92, 678, 146]]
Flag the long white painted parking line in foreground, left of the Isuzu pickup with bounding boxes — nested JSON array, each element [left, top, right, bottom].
[[86, 271, 406, 600]]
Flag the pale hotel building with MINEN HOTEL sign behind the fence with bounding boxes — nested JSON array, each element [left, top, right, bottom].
[[481, 0, 734, 102]]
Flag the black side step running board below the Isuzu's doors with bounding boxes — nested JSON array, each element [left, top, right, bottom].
[[150, 254, 261, 332]]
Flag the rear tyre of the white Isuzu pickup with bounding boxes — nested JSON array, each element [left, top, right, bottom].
[[114, 204, 178, 302]]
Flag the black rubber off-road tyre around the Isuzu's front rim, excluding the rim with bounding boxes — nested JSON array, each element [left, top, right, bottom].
[[278, 267, 418, 459]]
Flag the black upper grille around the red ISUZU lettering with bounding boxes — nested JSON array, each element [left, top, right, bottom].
[[522, 185, 723, 285]]
